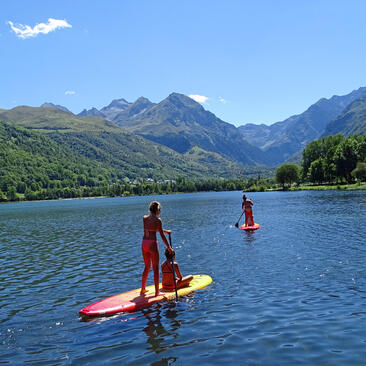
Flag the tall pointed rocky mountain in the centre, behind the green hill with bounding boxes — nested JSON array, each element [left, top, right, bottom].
[[114, 93, 266, 165]]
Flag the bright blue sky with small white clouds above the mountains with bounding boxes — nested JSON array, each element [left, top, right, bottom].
[[0, 0, 366, 125]]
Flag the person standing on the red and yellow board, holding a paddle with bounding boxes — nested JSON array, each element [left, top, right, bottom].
[[141, 201, 173, 296]]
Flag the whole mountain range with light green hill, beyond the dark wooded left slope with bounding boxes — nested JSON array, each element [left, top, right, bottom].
[[0, 88, 366, 182]]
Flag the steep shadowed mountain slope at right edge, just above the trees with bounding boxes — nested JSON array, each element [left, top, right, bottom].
[[322, 92, 366, 137]]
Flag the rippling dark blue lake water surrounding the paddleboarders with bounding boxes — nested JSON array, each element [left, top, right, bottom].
[[0, 191, 366, 366]]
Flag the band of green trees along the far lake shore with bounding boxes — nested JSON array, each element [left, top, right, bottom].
[[0, 135, 366, 202]]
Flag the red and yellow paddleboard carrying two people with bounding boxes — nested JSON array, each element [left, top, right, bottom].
[[79, 275, 212, 316]]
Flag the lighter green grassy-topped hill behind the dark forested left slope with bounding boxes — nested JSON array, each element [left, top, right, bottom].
[[0, 106, 261, 179]]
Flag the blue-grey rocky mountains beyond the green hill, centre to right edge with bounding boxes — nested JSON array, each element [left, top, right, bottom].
[[73, 87, 366, 166]]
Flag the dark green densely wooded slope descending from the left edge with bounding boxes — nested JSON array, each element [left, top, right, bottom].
[[0, 122, 114, 198]]
